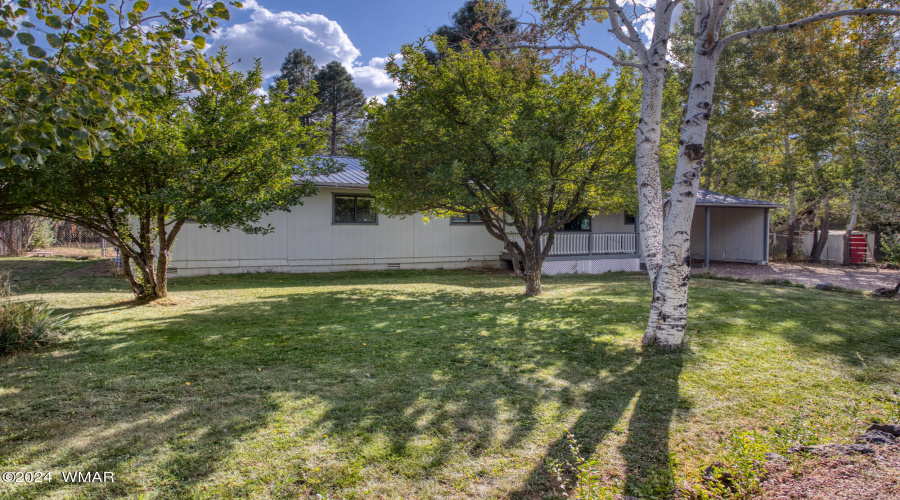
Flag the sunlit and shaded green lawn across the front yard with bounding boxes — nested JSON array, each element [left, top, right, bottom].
[[0, 259, 900, 499]]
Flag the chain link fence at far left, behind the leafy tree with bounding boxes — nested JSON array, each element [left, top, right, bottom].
[[0, 217, 115, 259]]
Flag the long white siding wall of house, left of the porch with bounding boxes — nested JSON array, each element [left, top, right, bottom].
[[172, 189, 502, 276]]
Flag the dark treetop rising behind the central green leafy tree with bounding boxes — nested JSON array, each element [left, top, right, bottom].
[[425, 0, 519, 62]]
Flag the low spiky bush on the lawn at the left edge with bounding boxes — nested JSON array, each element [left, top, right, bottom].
[[0, 275, 69, 354]]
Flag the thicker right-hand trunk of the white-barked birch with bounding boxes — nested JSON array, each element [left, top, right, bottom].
[[643, 18, 718, 349]]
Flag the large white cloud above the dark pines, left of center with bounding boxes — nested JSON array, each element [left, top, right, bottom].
[[211, 0, 397, 98]]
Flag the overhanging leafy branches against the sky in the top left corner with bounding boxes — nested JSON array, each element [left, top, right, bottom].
[[0, 0, 240, 168]]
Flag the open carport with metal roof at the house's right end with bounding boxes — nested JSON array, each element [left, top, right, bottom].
[[691, 189, 781, 267]]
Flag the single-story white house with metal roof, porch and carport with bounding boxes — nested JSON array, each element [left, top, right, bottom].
[[171, 157, 776, 276]]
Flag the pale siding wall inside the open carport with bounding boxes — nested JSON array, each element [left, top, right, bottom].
[[691, 207, 766, 264]]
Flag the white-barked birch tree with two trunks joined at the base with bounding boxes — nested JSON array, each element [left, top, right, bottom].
[[515, 0, 900, 349]]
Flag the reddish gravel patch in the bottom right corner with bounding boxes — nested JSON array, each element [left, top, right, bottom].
[[762, 444, 900, 500]]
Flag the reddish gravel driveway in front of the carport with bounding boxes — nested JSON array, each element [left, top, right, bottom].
[[692, 262, 900, 292]]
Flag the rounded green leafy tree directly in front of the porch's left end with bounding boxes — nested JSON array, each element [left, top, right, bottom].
[[361, 43, 639, 295]]
